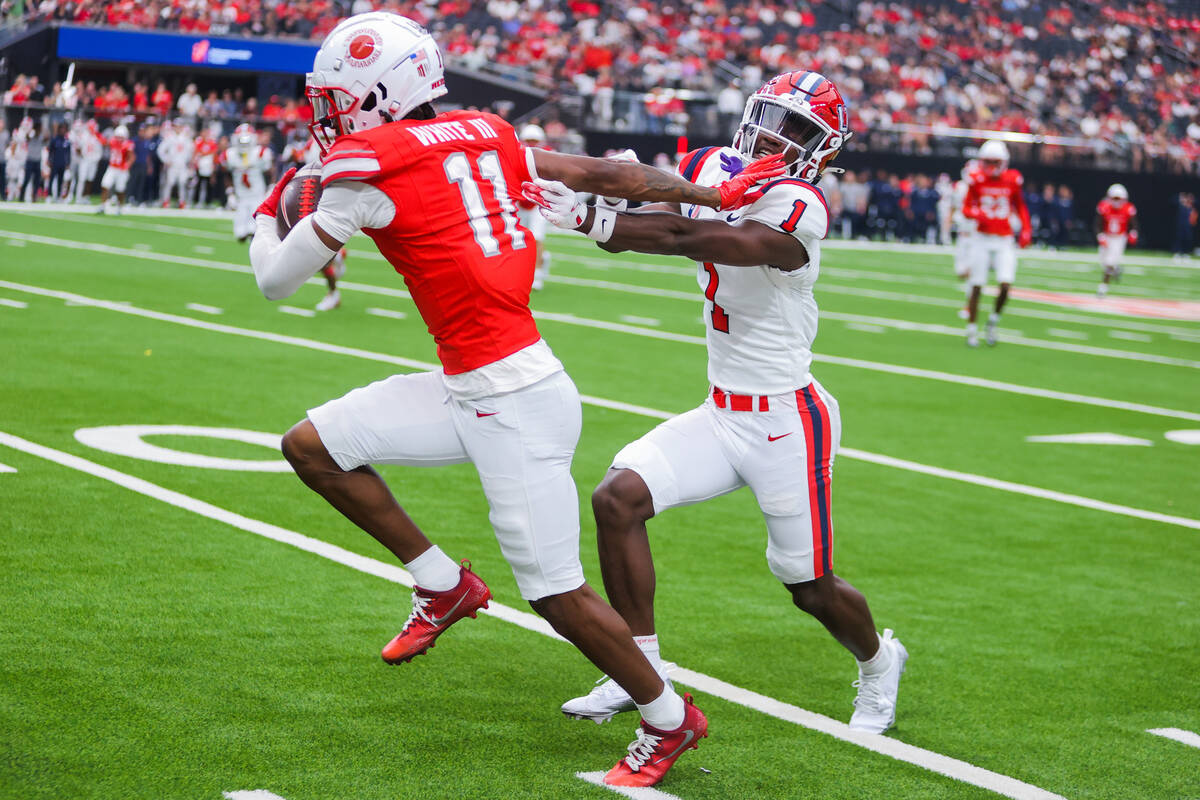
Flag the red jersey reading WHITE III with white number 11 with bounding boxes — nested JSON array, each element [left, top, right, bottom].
[[322, 112, 541, 375]]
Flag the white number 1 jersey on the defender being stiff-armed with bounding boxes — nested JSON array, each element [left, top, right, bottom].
[[679, 148, 829, 395]]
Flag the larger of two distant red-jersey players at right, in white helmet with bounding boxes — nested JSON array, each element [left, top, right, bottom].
[[962, 139, 1033, 347]]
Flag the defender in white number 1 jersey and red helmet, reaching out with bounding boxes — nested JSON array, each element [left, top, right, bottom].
[[526, 70, 908, 733]]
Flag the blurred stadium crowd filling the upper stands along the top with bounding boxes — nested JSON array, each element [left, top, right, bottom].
[[5, 0, 1200, 172]]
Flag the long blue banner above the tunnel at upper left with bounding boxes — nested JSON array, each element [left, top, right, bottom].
[[58, 25, 317, 76]]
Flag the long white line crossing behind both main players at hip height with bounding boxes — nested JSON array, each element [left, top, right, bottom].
[[0, 281, 1200, 530]]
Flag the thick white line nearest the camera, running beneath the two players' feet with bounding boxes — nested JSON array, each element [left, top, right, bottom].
[[0, 432, 1060, 800]]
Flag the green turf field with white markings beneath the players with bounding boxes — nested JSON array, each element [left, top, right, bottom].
[[0, 210, 1200, 800]]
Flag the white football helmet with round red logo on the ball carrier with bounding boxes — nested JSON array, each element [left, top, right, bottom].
[[305, 11, 446, 152]]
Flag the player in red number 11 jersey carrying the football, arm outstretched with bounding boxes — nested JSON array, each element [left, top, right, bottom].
[[250, 12, 782, 782]]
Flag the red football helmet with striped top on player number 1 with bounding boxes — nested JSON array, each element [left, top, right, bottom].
[[733, 70, 852, 184]]
